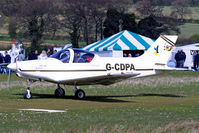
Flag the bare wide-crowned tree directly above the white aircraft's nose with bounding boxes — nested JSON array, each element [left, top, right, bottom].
[[20, 0, 54, 47]]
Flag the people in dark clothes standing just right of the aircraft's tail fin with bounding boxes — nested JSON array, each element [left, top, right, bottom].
[[175, 50, 186, 68]]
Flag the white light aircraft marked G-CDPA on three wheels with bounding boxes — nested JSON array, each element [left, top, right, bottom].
[[8, 35, 177, 99]]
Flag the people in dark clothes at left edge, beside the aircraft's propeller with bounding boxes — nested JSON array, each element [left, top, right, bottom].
[[0, 51, 11, 74]]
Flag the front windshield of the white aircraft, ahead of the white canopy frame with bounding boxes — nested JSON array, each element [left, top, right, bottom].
[[50, 49, 70, 63]]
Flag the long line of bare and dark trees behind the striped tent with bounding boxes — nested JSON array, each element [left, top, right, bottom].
[[0, 0, 193, 48]]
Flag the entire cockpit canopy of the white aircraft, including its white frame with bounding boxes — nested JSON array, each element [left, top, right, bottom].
[[51, 49, 95, 63]]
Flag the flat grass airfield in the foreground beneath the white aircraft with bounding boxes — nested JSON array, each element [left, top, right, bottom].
[[0, 72, 199, 133]]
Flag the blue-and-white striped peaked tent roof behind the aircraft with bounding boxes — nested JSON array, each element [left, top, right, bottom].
[[82, 30, 154, 52]]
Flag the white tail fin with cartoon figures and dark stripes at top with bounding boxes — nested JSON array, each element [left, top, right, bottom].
[[140, 35, 178, 69]]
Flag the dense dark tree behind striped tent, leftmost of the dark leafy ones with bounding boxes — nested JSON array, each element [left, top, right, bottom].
[[103, 9, 120, 38]]
